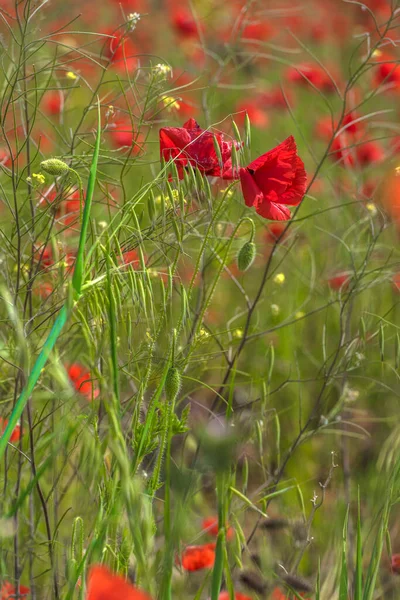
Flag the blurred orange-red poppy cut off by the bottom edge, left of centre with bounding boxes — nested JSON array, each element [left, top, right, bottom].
[[86, 565, 151, 600]]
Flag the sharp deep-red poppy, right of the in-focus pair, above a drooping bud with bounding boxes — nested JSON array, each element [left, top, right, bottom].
[[239, 136, 307, 221]]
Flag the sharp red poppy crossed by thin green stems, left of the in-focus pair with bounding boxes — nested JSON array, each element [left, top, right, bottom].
[[160, 119, 238, 179]]
